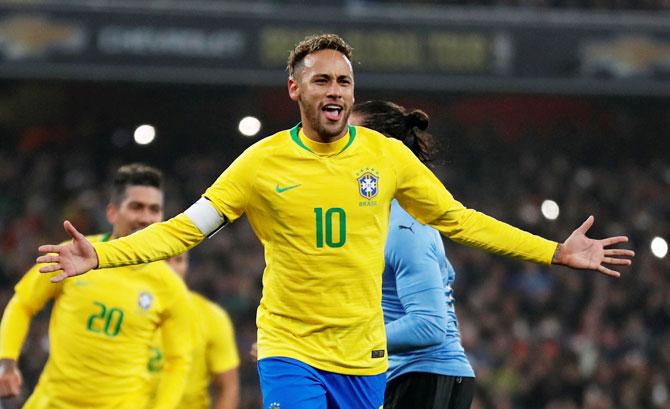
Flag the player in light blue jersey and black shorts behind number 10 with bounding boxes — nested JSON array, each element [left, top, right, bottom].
[[351, 101, 475, 409]]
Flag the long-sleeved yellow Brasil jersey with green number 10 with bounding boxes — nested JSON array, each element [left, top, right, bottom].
[[95, 126, 557, 375]]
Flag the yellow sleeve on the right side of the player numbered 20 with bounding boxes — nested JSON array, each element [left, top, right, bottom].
[[153, 273, 193, 409]]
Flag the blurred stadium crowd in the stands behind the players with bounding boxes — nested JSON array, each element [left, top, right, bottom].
[[0, 90, 670, 409]]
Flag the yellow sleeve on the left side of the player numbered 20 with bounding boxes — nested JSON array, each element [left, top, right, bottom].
[[0, 264, 62, 360]]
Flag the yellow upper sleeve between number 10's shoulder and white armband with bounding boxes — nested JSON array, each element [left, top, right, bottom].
[[203, 145, 262, 222]]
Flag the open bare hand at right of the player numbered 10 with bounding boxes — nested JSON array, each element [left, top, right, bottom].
[[552, 216, 635, 277]]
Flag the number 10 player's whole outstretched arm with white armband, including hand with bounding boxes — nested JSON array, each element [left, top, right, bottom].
[[37, 144, 266, 282]]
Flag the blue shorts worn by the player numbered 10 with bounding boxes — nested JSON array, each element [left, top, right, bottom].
[[258, 357, 386, 409]]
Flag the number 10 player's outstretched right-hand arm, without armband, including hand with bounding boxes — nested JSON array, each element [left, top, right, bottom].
[[394, 139, 634, 277]]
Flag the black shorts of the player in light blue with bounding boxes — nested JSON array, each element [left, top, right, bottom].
[[384, 372, 475, 409]]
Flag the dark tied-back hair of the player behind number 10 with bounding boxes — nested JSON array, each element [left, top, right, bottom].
[[353, 101, 436, 163]]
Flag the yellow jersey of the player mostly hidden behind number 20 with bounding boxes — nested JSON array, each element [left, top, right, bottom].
[[147, 291, 240, 409]]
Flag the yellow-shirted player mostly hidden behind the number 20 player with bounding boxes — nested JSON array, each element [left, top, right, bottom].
[[149, 253, 240, 409]]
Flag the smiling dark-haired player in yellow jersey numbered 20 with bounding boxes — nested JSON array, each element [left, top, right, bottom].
[[0, 164, 191, 409]]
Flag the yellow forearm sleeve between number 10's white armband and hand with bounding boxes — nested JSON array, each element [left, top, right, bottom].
[[93, 213, 205, 268]]
